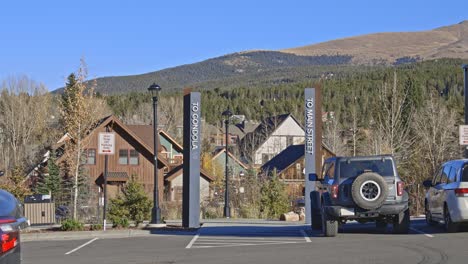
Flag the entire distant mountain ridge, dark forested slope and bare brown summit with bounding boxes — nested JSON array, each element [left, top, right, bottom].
[[56, 20, 468, 94]]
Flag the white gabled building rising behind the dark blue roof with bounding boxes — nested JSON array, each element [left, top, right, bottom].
[[239, 114, 305, 167]]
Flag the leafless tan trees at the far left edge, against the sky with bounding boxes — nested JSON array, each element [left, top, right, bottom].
[[0, 76, 51, 171]]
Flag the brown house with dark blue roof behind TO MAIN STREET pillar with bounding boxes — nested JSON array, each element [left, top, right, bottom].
[[260, 144, 335, 196]]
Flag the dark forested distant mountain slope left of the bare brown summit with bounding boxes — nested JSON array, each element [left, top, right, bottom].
[[57, 51, 351, 94]]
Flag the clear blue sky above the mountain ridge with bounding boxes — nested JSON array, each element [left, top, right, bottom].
[[0, 0, 468, 90]]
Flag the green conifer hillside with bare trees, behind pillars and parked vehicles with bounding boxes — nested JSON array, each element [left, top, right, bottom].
[[106, 59, 466, 205]]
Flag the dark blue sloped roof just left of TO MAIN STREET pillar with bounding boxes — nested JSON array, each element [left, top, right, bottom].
[[261, 144, 304, 174]]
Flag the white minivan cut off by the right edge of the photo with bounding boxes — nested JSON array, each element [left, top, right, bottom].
[[423, 159, 468, 232]]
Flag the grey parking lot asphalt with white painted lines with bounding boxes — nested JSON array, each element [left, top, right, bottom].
[[22, 219, 468, 264]]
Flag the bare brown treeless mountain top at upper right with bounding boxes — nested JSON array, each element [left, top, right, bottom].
[[284, 20, 468, 64]]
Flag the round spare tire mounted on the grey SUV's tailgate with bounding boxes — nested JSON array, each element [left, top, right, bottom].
[[351, 172, 388, 210]]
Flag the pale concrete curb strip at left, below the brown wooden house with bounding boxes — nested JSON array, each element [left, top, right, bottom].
[[21, 229, 157, 242]]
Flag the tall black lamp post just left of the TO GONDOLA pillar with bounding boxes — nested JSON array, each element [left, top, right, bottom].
[[148, 83, 161, 224]]
